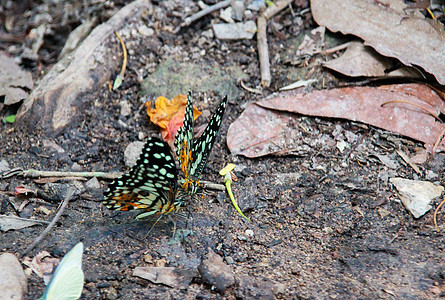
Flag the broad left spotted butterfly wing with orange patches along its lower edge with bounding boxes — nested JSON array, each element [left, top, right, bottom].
[[104, 137, 183, 219]]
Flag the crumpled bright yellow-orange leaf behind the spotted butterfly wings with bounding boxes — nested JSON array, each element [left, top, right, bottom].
[[145, 94, 201, 145]]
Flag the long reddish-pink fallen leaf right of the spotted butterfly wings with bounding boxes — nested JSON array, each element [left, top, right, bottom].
[[227, 84, 445, 157]]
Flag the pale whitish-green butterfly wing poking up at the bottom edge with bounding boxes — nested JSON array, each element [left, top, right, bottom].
[[40, 243, 84, 300]]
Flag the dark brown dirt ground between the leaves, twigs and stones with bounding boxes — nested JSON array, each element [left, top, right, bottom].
[[0, 0, 445, 299]]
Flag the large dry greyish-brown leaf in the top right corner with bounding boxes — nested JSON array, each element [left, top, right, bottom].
[[311, 0, 445, 85]]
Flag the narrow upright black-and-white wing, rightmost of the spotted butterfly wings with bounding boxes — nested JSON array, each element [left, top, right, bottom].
[[190, 96, 227, 178]]
